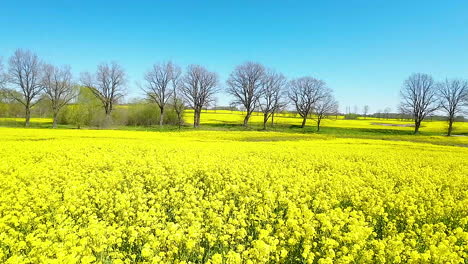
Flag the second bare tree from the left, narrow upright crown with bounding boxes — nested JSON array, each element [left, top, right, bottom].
[[42, 64, 76, 128]]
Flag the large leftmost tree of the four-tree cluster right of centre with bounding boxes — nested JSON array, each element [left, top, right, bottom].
[[227, 62, 265, 126]]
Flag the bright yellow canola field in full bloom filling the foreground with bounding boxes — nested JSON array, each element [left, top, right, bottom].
[[0, 128, 468, 264]]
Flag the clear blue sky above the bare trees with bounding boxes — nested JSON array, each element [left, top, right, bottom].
[[0, 0, 468, 112]]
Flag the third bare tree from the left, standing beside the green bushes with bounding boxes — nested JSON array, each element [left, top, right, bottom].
[[81, 62, 127, 125]]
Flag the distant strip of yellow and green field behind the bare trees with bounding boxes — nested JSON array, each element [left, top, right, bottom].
[[0, 110, 468, 146]]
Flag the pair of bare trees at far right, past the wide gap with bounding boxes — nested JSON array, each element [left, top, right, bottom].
[[400, 73, 468, 136]]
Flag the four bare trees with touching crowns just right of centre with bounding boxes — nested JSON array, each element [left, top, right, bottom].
[[226, 62, 338, 130]]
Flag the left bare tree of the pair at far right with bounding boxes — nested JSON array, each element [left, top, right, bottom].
[[400, 73, 438, 134]]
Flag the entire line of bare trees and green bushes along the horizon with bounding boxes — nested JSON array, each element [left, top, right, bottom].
[[0, 49, 468, 135]]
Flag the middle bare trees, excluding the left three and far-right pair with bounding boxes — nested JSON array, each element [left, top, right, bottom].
[[140, 62, 338, 129]]
